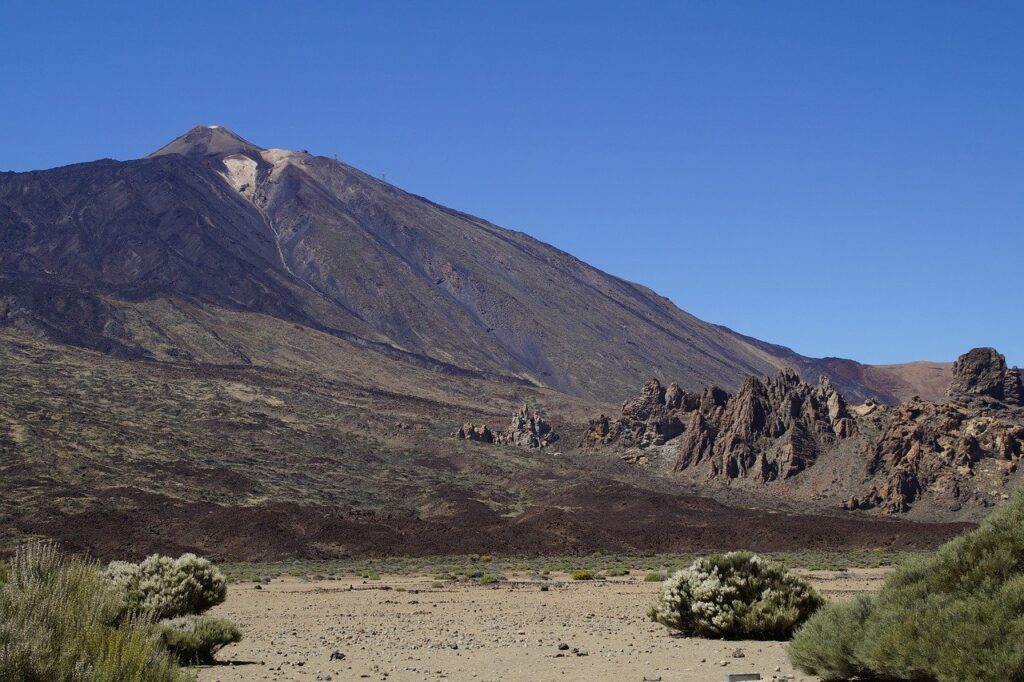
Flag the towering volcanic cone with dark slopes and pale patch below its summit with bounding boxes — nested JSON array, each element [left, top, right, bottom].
[[0, 126, 948, 402]]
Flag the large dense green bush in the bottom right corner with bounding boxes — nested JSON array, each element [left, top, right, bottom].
[[790, 491, 1024, 682]]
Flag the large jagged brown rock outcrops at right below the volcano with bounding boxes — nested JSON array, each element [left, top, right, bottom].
[[582, 348, 1024, 517]]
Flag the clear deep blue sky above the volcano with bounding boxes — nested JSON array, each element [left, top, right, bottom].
[[0, 0, 1024, 365]]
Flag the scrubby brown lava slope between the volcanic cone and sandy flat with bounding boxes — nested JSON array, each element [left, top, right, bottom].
[[0, 322, 964, 559]]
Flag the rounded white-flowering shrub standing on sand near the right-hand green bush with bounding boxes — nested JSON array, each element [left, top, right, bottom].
[[648, 552, 823, 639]]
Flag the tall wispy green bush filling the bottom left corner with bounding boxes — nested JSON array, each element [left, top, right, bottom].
[[0, 543, 189, 682]]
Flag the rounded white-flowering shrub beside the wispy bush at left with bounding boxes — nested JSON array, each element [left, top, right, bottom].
[[103, 554, 227, 620]]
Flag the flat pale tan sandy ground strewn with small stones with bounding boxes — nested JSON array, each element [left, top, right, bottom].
[[193, 568, 889, 682]]
